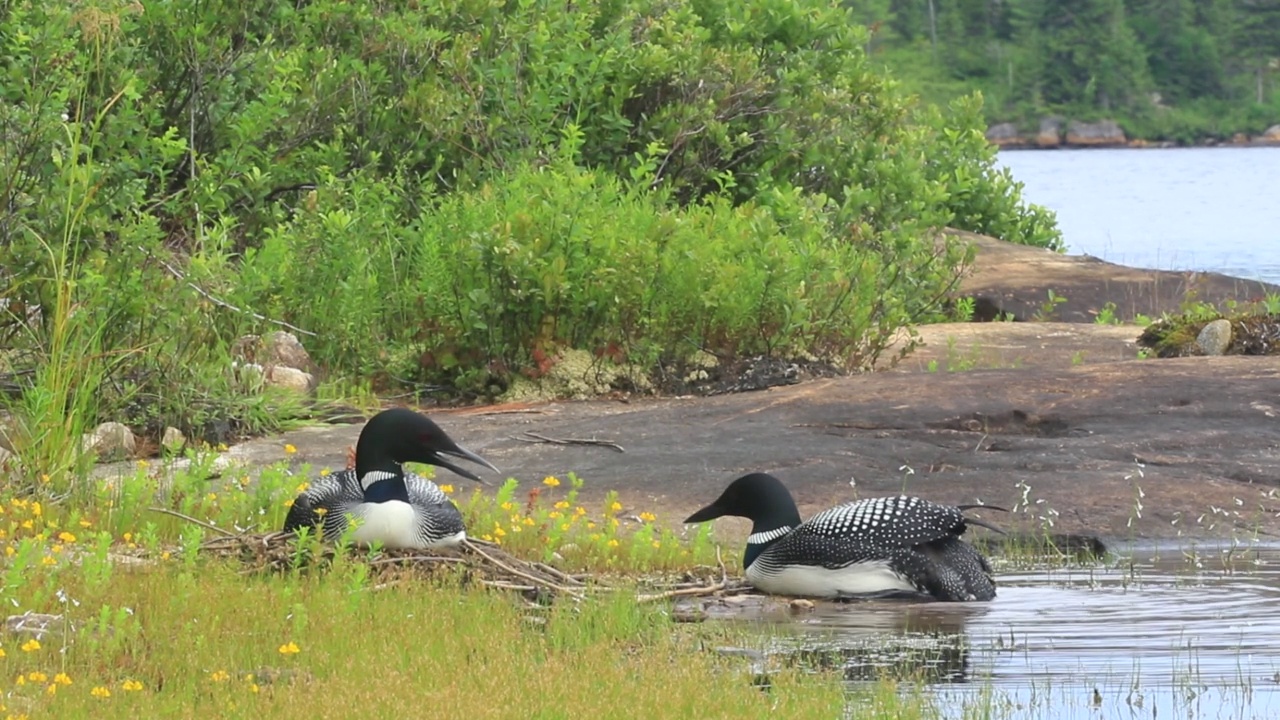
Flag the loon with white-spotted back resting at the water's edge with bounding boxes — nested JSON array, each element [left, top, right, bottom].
[[685, 473, 1002, 602]]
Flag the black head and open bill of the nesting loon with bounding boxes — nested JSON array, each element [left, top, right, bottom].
[[356, 407, 499, 491]]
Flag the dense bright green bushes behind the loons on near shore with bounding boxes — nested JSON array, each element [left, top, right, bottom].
[[0, 0, 1059, 474]]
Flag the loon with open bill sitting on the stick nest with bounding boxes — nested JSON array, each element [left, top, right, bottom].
[[284, 407, 498, 550]]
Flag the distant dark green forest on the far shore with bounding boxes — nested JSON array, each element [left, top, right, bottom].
[[845, 0, 1280, 141]]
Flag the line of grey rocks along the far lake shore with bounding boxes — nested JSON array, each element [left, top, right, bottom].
[[987, 118, 1280, 150]]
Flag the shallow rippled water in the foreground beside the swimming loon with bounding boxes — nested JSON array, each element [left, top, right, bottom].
[[732, 546, 1280, 720]]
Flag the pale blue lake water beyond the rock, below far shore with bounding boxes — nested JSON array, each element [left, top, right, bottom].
[[998, 147, 1280, 283]]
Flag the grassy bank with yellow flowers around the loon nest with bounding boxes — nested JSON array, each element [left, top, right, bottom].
[[0, 458, 928, 719]]
